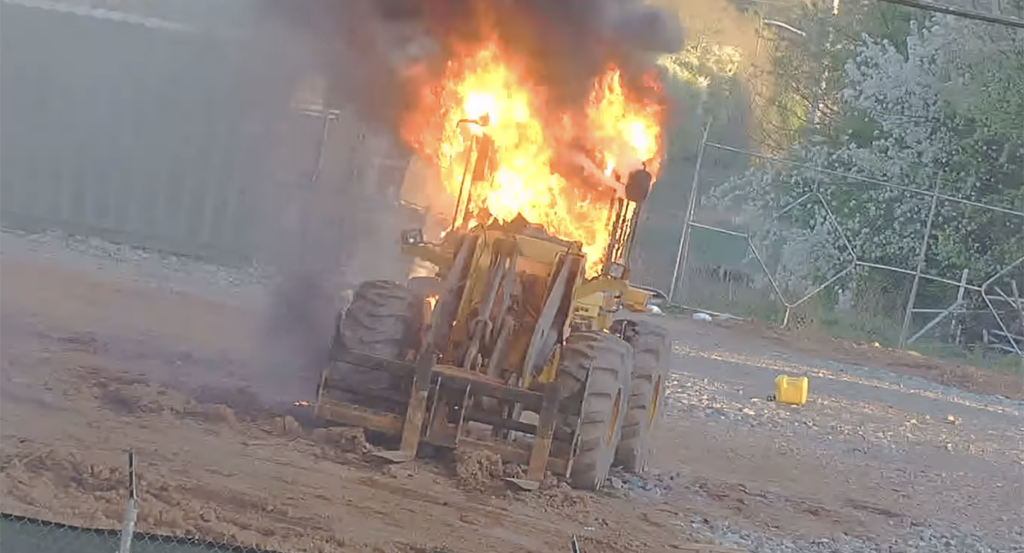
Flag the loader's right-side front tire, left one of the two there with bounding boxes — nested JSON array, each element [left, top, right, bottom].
[[557, 331, 633, 491]]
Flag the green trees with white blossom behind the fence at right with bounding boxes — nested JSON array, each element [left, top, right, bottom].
[[706, 2, 1024, 358]]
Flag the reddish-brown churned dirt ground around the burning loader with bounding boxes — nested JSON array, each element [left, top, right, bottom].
[[0, 251, 1024, 553]]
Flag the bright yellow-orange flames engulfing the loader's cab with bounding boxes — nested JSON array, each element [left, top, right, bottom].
[[402, 42, 662, 274]]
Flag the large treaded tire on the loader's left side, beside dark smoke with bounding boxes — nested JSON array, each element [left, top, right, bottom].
[[332, 281, 424, 407]]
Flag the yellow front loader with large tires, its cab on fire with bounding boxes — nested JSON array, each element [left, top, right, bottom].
[[315, 142, 670, 490]]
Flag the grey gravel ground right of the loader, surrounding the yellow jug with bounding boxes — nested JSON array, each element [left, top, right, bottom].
[[638, 321, 1024, 552]]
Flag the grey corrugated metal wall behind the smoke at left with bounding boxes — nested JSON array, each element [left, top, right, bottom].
[[0, 0, 399, 262]]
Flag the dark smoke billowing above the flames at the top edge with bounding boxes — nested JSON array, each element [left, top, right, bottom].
[[263, 0, 683, 128]]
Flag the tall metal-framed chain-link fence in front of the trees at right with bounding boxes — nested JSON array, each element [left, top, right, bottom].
[[655, 118, 1024, 364]]
